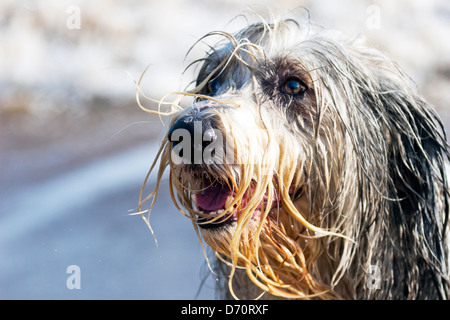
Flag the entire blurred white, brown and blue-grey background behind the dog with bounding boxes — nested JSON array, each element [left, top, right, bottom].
[[0, 0, 450, 299]]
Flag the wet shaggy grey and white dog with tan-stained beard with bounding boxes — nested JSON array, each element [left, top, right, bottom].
[[137, 18, 450, 299]]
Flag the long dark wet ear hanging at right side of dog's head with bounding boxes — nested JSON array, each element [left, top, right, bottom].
[[377, 69, 449, 298]]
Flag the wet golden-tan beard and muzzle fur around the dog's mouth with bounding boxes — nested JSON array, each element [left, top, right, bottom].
[[154, 110, 348, 298]]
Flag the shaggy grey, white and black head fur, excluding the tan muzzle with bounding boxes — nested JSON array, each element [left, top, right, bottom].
[[139, 19, 450, 299]]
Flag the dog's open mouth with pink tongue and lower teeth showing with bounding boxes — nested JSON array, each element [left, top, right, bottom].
[[191, 181, 281, 229]]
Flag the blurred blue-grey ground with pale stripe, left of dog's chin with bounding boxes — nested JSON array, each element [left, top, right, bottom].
[[0, 145, 214, 299]]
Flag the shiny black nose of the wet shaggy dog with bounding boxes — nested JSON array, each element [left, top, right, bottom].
[[168, 113, 217, 164]]
